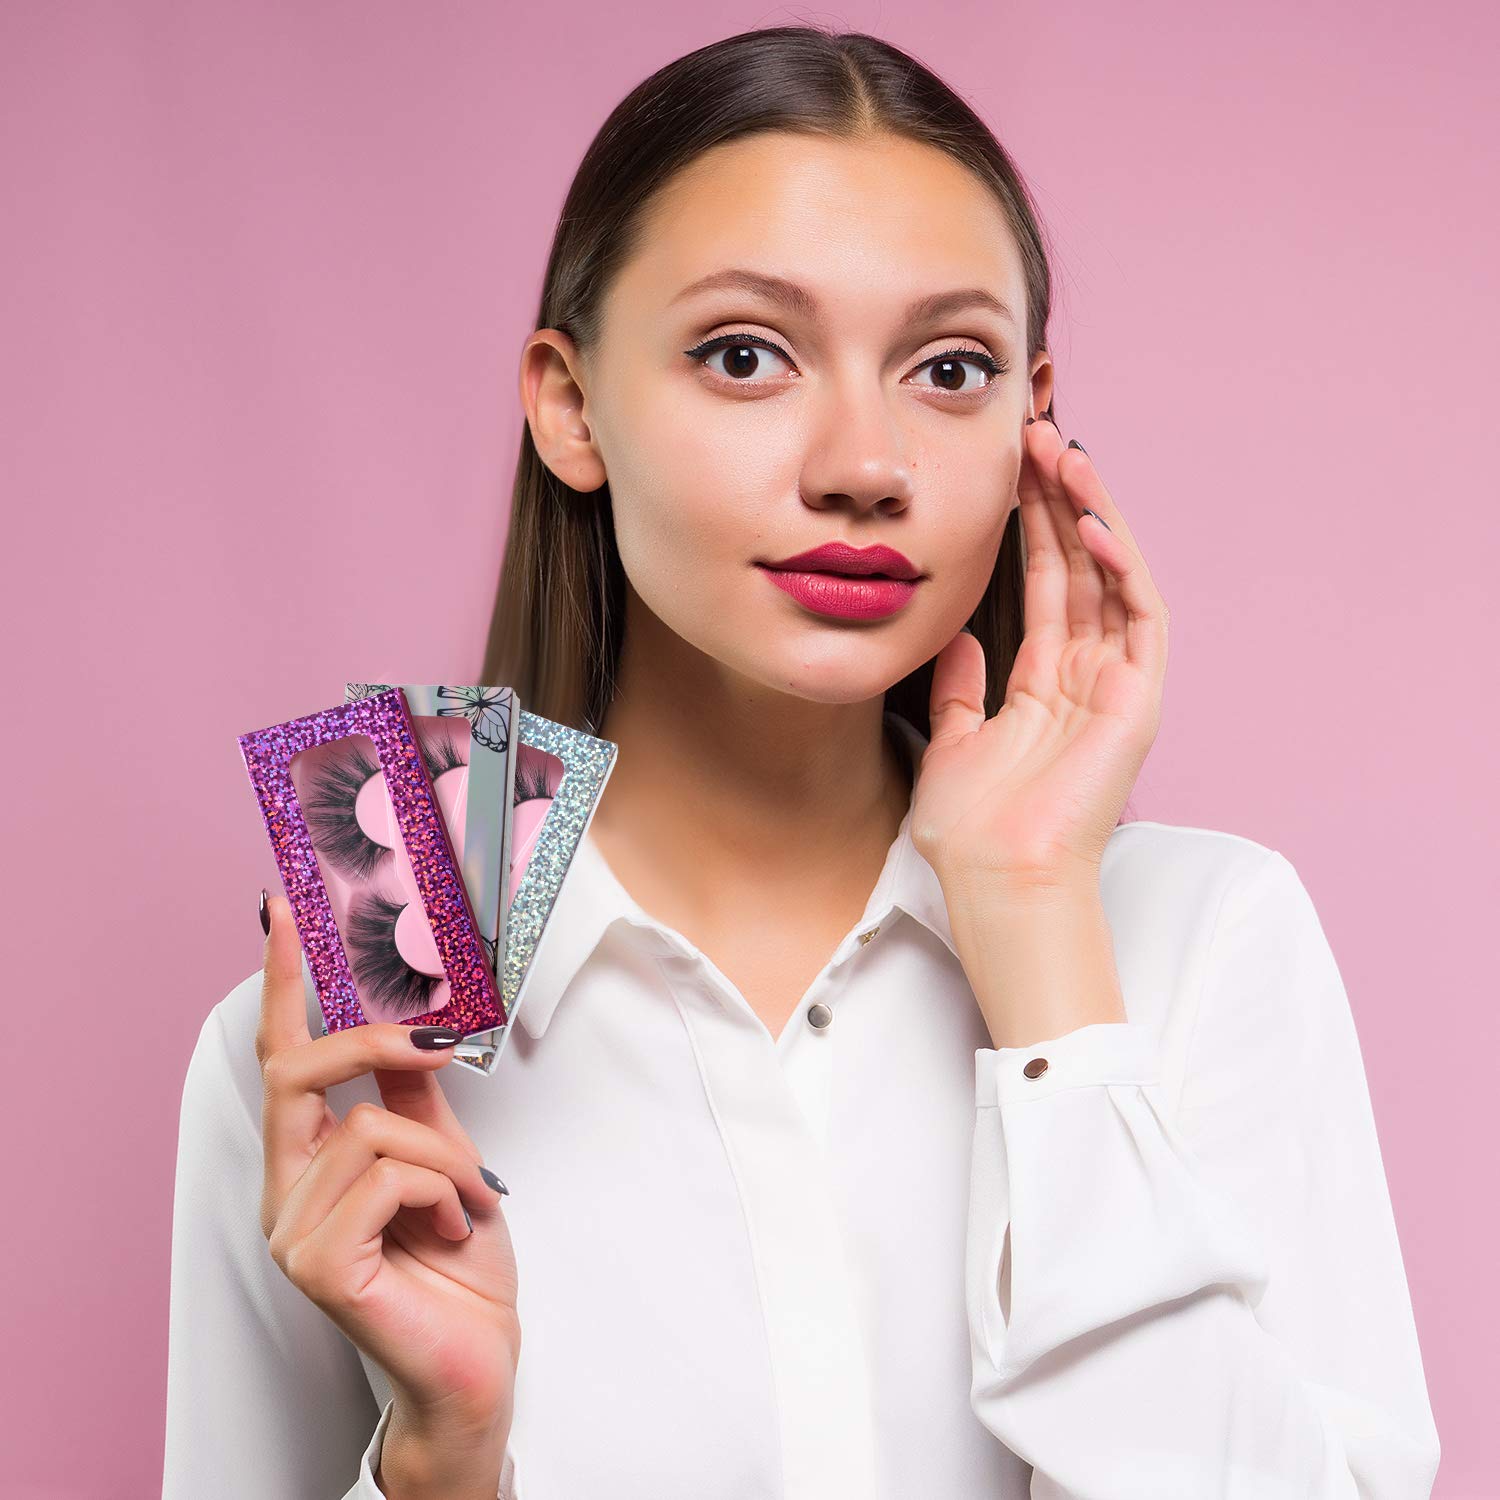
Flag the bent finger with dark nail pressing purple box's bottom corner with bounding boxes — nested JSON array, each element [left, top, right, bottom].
[[261, 1008, 456, 1223]]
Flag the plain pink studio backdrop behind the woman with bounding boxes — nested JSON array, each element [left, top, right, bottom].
[[0, 0, 1500, 1500]]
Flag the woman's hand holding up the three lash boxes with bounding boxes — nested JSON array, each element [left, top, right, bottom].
[[255, 896, 521, 1464]]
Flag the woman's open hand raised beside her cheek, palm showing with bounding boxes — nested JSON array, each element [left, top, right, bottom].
[[912, 419, 1169, 890]]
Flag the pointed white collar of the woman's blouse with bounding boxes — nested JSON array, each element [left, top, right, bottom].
[[515, 710, 957, 1037]]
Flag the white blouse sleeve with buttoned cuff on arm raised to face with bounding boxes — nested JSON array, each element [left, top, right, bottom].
[[966, 851, 1440, 1500]]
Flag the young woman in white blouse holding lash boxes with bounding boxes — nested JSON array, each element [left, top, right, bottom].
[[165, 27, 1439, 1500]]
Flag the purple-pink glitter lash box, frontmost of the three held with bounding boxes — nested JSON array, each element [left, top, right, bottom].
[[239, 687, 509, 1037]]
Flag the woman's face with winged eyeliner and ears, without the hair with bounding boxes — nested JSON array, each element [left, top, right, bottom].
[[524, 134, 1052, 702]]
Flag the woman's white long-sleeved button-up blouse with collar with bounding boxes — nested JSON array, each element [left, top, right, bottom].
[[164, 714, 1439, 1500]]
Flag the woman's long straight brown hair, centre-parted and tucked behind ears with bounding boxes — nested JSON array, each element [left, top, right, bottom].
[[480, 26, 1052, 735]]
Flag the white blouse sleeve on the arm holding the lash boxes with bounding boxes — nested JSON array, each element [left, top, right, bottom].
[[162, 975, 521, 1500]]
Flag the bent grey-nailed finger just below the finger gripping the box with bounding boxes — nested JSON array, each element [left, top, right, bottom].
[[278, 1100, 500, 1242]]
